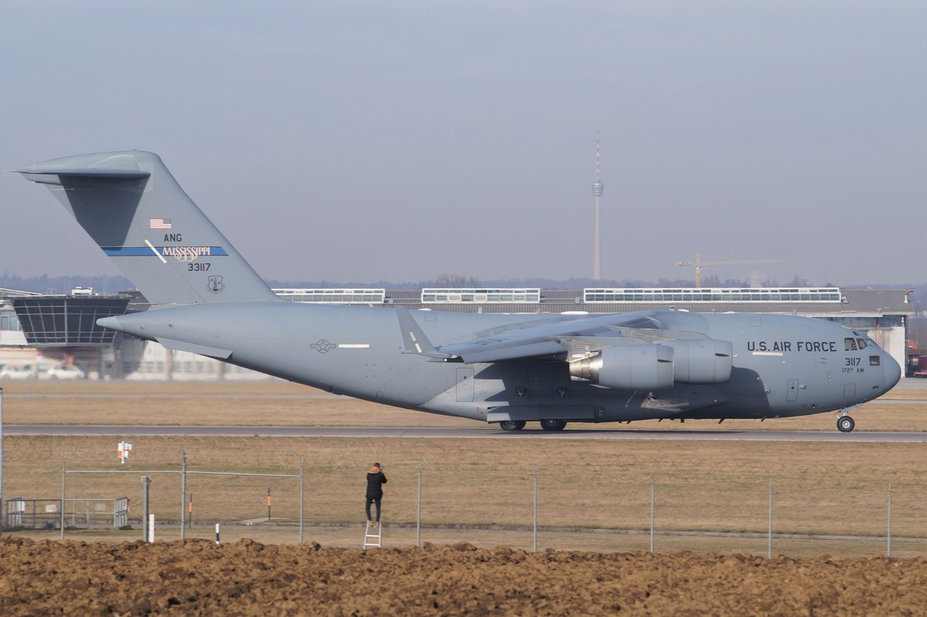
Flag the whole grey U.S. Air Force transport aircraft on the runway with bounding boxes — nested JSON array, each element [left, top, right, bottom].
[[17, 151, 901, 432]]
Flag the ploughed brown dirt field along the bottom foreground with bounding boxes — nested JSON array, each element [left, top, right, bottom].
[[0, 538, 927, 617]]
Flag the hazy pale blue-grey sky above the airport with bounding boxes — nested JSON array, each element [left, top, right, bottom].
[[0, 0, 927, 285]]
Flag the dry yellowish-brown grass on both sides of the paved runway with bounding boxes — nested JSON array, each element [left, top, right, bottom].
[[3, 381, 927, 555]]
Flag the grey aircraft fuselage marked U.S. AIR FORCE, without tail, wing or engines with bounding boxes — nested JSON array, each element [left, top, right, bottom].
[[99, 303, 900, 422]]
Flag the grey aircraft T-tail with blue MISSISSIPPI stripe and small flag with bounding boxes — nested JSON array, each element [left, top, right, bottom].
[[16, 150, 279, 306]]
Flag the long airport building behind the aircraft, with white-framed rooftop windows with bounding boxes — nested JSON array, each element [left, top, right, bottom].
[[0, 287, 914, 380]]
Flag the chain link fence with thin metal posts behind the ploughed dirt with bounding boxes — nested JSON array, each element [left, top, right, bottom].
[[6, 447, 927, 556]]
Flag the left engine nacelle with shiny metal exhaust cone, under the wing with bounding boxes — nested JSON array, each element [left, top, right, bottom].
[[570, 344, 673, 390]]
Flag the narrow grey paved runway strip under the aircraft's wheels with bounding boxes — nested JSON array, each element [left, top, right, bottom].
[[3, 424, 927, 443]]
